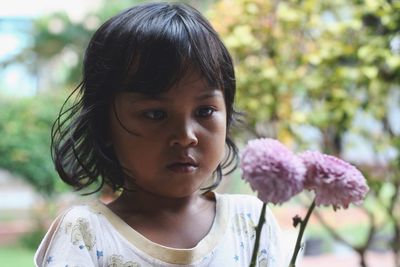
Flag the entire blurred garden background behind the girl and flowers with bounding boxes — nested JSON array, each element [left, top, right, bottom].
[[0, 0, 400, 267]]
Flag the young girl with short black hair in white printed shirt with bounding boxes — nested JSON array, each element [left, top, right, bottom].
[[35, 3, 282, 267]]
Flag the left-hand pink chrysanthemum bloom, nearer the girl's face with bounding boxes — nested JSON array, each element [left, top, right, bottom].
[[240, 138, 306, 204]]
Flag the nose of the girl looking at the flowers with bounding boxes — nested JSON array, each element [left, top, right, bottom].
[[170, 121, 199, 147]]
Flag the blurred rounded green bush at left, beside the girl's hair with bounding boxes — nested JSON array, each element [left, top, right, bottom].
[[0, 94, 65, 196]]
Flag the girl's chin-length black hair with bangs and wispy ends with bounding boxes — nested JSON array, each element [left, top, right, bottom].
[[51, 3, 238, 193]]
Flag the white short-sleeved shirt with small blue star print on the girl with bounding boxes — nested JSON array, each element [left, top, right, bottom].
[[35, 194, 284, 267]]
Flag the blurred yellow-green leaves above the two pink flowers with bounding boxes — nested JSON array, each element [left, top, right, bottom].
[[209, 0, 400, 150]]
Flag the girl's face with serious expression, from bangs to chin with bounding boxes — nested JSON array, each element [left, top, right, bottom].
[[111, 74, 226, 197]]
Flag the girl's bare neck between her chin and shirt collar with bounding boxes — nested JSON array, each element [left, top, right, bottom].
[[108, 188, 216, 248]]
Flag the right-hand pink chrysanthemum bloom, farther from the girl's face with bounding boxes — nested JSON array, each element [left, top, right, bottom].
[[299, 151, 369, 209]]
